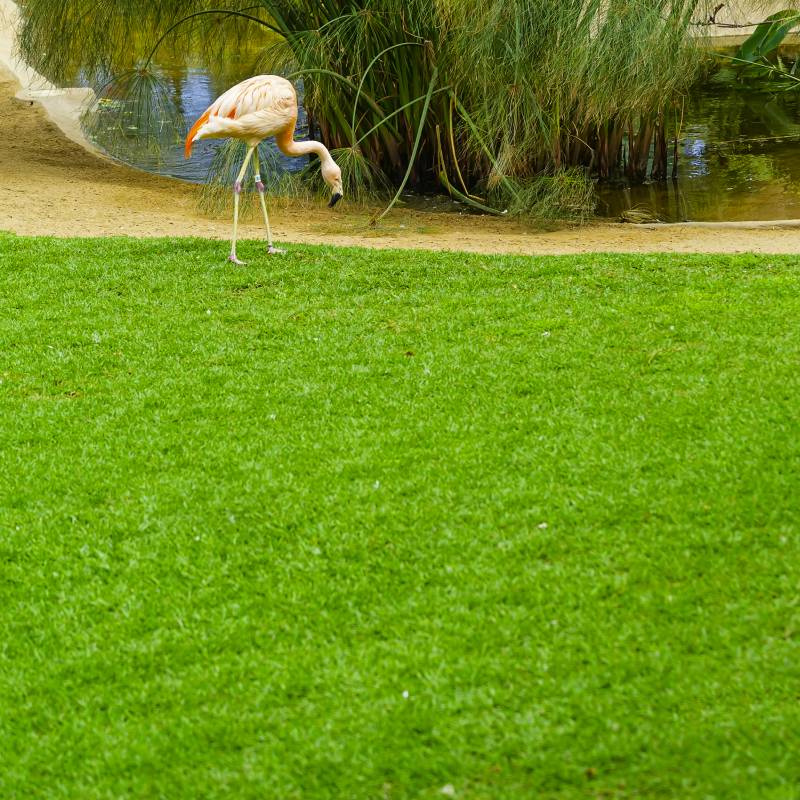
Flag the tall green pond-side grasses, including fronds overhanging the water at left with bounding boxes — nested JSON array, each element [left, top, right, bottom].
[[21, 0, 710, 218]]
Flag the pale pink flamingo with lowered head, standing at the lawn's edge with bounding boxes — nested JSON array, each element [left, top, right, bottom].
[[185, 75, 343, 265]]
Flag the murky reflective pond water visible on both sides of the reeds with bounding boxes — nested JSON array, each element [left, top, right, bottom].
[[81, 50, 800, 222]]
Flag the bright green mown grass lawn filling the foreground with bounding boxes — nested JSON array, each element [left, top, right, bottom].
[[0, 236, 800, 800]]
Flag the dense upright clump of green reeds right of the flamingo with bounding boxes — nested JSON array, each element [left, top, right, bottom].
[[252, 0, 703, 206]]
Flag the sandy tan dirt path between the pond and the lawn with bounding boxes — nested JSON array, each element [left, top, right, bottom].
[[0, 72, 800, 254]]
